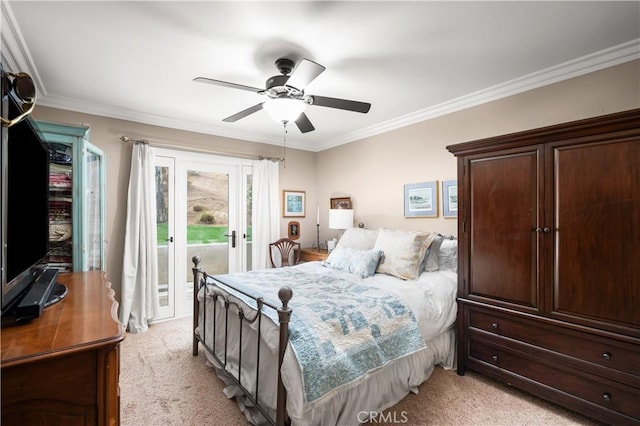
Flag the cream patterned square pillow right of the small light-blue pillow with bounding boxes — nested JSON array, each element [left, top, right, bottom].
[[373, 229, 431, 280]]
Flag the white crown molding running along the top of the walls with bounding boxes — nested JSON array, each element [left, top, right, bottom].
[[0, 0, 640, 152]]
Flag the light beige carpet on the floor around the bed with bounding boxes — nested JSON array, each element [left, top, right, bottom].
[[120, 318, 597, 426]]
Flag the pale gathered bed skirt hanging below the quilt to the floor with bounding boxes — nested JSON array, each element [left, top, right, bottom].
[[199, 327, 455, 425]]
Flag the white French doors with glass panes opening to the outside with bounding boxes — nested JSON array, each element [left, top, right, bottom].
[[154, 148, 252, 321]]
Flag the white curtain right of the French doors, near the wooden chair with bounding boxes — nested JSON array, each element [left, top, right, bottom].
[[251, 160, 280, 270]]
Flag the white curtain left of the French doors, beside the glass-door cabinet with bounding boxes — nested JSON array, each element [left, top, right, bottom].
[[120, 143, 160, 333]]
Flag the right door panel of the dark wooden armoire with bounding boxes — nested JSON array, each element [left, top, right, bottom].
[[553, 139, 640, 327]]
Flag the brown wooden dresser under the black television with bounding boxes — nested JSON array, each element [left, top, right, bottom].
[[1, 271, 124, 426]]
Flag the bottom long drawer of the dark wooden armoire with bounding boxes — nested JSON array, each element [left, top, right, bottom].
[[467, 339, 640, 420]]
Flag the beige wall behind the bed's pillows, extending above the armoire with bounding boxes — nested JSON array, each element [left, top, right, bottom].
[[316, 61, 640, 239]]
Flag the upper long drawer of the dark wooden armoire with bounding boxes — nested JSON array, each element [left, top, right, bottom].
[[467, 308, 640, 376]]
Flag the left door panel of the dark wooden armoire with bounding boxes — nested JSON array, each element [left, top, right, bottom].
[[469, 150, 539, 307]]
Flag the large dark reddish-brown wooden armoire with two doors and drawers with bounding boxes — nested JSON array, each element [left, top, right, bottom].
[[447, 110, 640, 425]]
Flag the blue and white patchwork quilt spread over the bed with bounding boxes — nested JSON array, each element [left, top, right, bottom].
[[214, 267, 425, 401]]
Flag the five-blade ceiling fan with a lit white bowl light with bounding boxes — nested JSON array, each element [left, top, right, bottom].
[[193, 58, 371, 133]]
